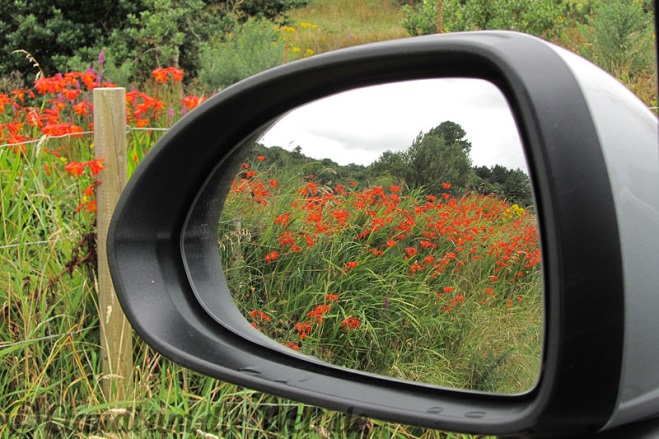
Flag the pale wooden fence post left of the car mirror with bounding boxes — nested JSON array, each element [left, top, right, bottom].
[[94, 88, 133, 402]]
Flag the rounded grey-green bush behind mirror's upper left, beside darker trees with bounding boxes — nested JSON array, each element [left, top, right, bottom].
[[198, 20, 284, 93]]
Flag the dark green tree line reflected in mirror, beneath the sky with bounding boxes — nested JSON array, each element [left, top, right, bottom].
[[254, 121, 533, 206]]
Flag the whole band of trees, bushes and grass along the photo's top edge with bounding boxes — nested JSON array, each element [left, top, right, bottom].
[[0, 0, 657, 107]]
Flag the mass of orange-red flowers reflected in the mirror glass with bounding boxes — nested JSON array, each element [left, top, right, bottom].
[[228, 156, 541, 347]]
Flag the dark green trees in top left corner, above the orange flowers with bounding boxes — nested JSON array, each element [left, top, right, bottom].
[[0, 0, 307, 85]]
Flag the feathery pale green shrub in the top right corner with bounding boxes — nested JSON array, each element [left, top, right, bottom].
[[581, 0, 654, 76]]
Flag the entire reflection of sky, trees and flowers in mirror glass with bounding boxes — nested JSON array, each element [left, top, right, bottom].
[[219, 78, 543, 393]]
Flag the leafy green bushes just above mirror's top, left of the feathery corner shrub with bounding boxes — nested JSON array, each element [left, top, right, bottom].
[[402, 0, 565, 37]]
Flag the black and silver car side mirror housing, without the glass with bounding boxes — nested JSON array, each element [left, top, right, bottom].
[[108, 31, 659, 437]]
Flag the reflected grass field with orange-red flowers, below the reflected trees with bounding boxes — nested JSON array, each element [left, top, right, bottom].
[[219, 156, 542, 393]]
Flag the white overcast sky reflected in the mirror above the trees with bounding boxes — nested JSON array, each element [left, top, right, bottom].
[[261, 78, 526, 169]]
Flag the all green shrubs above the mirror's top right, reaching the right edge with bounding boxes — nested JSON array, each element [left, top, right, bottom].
[[398, 0, 657, 107]]
